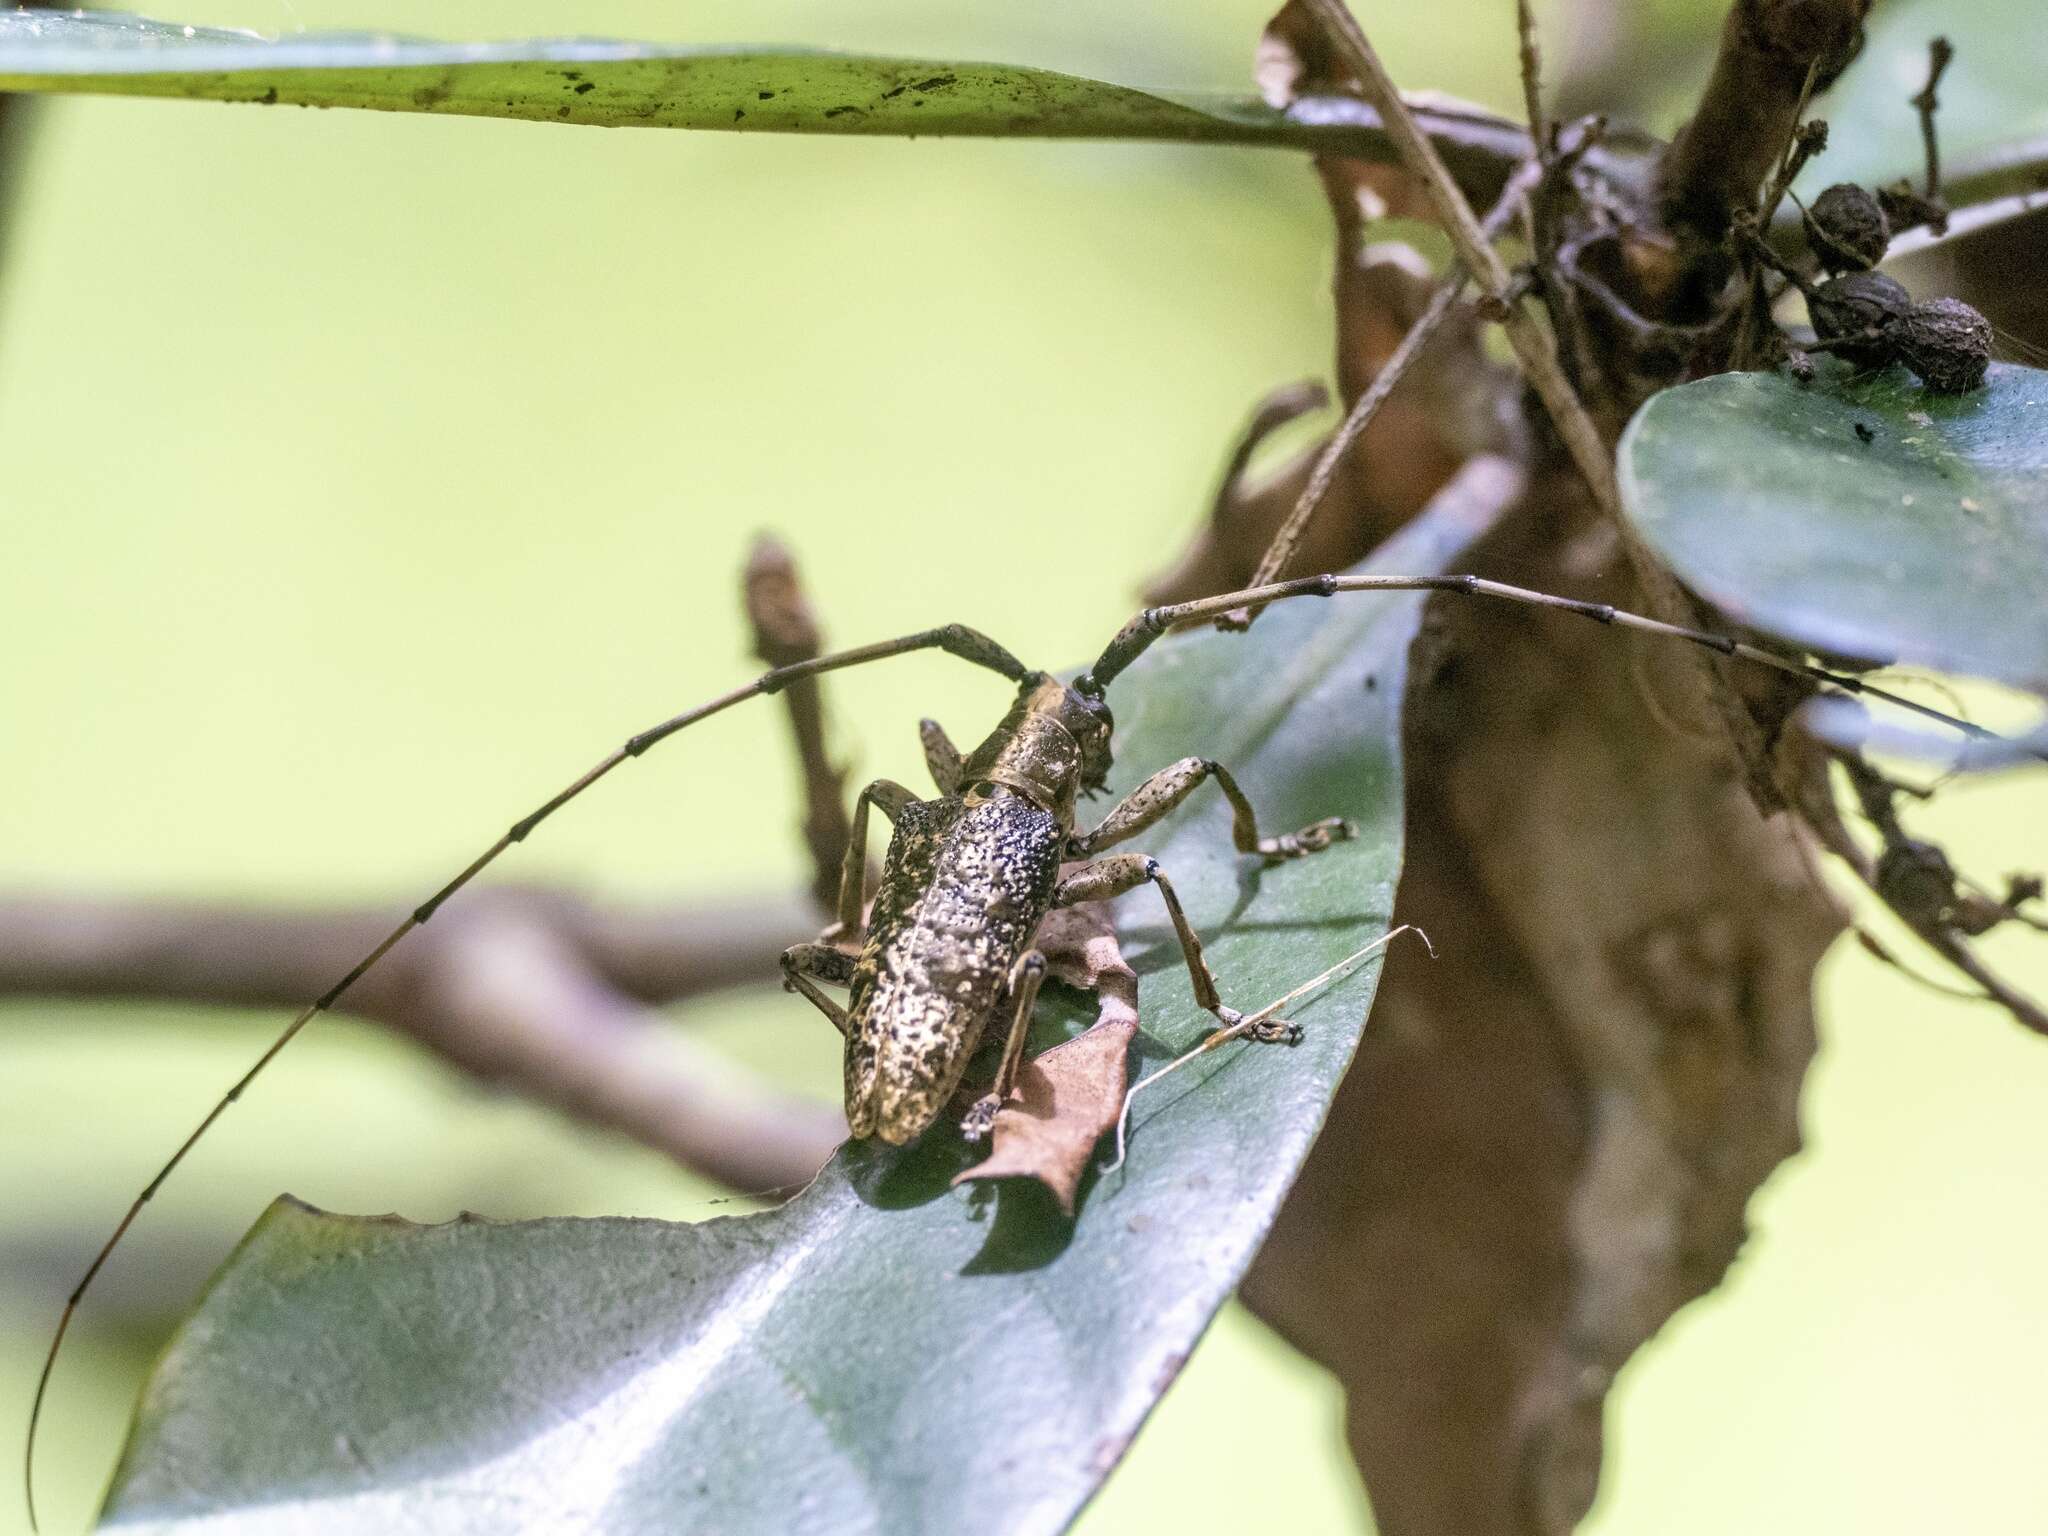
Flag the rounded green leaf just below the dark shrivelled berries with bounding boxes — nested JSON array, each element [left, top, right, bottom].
[[1620, 362, 2048, 690]]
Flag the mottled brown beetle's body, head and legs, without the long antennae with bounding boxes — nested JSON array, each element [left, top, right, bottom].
[[782, 667, 1354, 1145]]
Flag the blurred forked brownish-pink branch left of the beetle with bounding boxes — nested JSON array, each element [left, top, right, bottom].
[[0, 887, 846, 1190]]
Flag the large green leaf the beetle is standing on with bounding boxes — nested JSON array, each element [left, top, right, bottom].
[[104, 495, 1477, 1536]]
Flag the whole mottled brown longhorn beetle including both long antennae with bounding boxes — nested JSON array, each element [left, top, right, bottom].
[[25, 561, 1991, 1524]]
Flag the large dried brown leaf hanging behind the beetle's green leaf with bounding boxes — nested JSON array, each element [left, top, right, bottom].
[[1245, 481, 1841, 1536]]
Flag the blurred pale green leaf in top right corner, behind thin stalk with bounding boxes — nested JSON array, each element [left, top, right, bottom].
[[1798, 0, 2048, 209]]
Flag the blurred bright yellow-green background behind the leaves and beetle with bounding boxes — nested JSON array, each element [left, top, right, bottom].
[[0, 0, 2048, 1536]]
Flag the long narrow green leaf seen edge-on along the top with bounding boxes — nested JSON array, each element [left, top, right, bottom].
[[0, 10, 1528, 195]]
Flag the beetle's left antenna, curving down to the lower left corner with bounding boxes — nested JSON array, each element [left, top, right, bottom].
[[23, 625, 1032, 1532]]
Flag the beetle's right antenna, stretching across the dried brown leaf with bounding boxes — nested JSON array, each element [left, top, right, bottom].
[[1073, 575, 2023, 760]]
